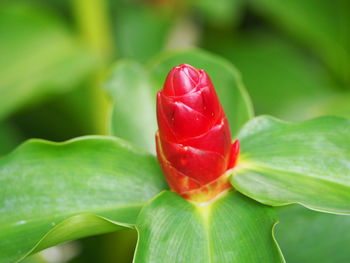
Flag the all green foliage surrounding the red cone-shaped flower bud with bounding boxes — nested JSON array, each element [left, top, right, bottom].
[[0, 0, 350, 263]]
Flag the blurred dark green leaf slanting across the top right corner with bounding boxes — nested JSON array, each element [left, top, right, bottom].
[[250, 0, 350, 83]]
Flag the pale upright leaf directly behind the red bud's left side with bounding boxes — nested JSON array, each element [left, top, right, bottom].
[[105, 61, 157, 153]]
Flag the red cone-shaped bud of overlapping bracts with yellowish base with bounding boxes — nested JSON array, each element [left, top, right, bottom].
[[156, 64, 239, 202]]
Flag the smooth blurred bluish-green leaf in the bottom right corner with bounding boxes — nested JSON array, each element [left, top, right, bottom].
[[275, 205, 350, 263]]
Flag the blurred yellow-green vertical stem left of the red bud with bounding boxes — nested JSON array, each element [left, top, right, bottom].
[[72, 0, 115, 134]]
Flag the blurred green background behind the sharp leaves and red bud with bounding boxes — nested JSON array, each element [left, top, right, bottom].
[[0, 0, 350, 263]]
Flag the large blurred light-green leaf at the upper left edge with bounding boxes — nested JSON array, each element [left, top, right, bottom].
[[0, 3, 99, 119]]
